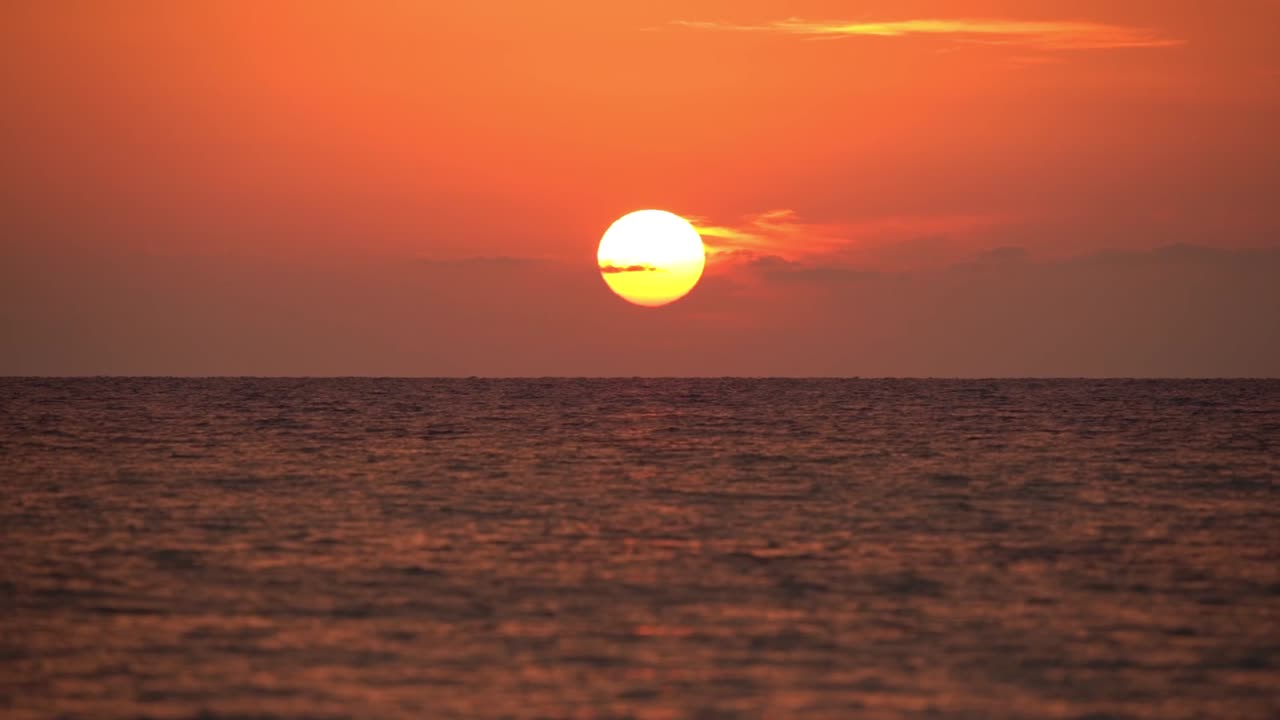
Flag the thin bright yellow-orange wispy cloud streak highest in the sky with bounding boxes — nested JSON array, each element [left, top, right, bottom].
[[673, 18, 1184, 50]]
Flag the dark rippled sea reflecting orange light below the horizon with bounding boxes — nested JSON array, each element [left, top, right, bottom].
[[0, 379, 1280, 719]]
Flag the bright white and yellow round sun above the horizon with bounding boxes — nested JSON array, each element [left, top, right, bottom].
[[596, 210, 707, 307]]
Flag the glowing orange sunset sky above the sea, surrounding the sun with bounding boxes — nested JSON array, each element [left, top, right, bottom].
[[0, 0, 1280, 375]]
